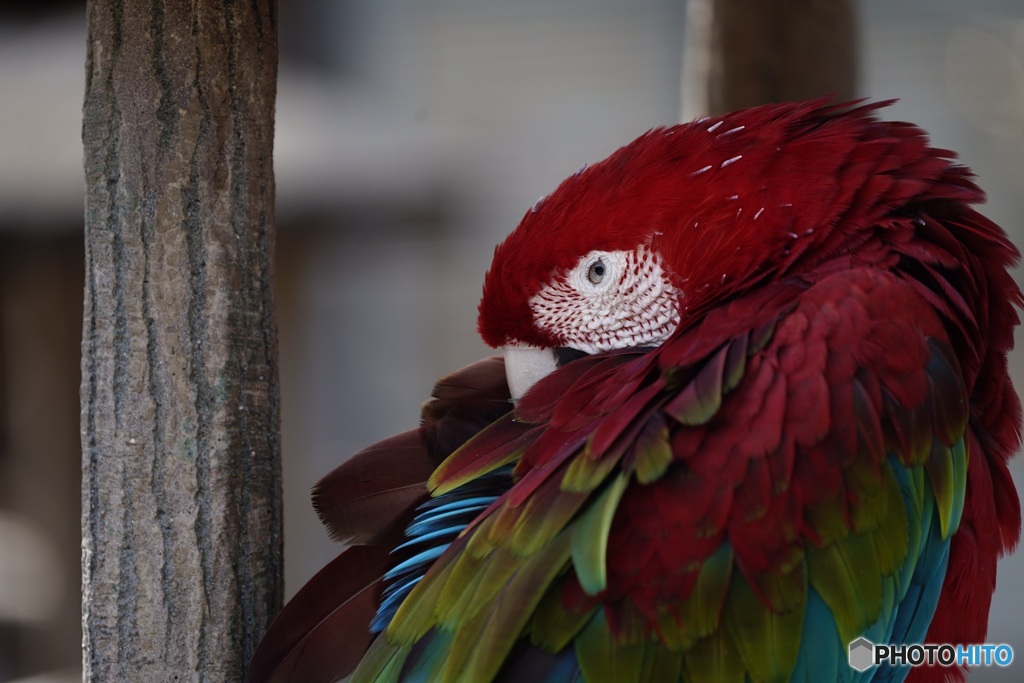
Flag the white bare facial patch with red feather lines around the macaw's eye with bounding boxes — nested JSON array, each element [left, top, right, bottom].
[[529, 246, 680, 353]]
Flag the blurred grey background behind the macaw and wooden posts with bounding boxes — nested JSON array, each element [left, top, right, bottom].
[[0, 0, 1024, 683]]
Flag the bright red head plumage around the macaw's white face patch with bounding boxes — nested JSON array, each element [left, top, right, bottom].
[[478, 99, 982, 346]]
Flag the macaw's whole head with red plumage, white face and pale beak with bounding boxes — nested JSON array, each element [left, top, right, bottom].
[[478, 99, 948, 396]]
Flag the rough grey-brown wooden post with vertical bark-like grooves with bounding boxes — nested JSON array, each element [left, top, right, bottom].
[[81, 0, 282, 682]]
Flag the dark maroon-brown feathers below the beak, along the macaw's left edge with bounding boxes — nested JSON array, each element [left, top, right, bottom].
[[246, 356, 512, 683]]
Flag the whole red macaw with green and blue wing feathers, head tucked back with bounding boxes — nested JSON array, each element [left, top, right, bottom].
[[243, 100, 1022, 683]]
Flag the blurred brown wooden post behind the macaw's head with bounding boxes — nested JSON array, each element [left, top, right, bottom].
[[682, 0, 857, 121]]
